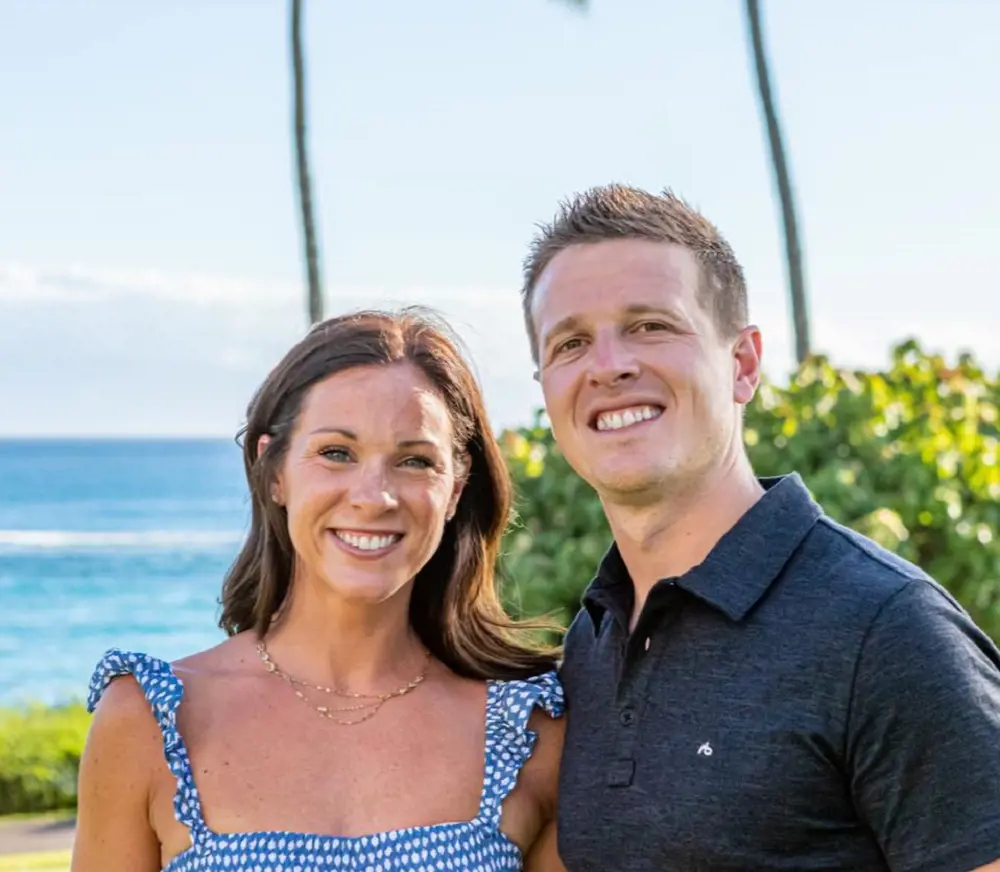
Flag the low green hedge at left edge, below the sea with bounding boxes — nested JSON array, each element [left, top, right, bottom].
[[0, 703, 90, 814]]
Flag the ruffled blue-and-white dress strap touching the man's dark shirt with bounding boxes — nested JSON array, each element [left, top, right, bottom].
[[480, 672, 566, 827]]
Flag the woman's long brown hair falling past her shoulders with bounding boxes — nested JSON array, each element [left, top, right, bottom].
[[219, 309, 557, 679]]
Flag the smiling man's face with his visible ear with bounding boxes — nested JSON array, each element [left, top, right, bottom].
[[532, 239, 760, 503]]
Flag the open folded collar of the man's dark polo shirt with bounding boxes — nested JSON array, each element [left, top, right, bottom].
[[583, 473, 822, 633]]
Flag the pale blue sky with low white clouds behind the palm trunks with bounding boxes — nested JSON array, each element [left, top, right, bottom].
[[0, 0, 1000, 436]]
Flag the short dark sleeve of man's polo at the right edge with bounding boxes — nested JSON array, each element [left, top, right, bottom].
[[846, 580, 1000, 872]]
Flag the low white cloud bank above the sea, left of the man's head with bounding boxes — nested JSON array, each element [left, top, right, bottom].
[[0, 264, 541, 435]]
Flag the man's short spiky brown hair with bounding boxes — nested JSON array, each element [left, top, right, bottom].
[[521, 184, 748, 363]]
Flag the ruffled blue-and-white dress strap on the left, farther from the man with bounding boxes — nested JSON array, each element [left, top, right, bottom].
[[87, 648, 208, 845]]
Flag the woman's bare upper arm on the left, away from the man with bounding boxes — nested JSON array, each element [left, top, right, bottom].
[[70, 677, 163, 872]]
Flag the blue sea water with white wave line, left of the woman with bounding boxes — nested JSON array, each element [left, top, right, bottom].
[[0, 440, 249, 705]]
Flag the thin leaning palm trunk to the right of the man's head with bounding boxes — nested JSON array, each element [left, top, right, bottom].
[[746, 0, 810, 364]]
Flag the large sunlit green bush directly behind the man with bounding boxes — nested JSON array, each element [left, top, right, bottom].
[[503, 341, 1000, 640]]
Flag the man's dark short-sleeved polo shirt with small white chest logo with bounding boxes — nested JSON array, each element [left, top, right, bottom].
[[559, 475, 1000, 872]]
